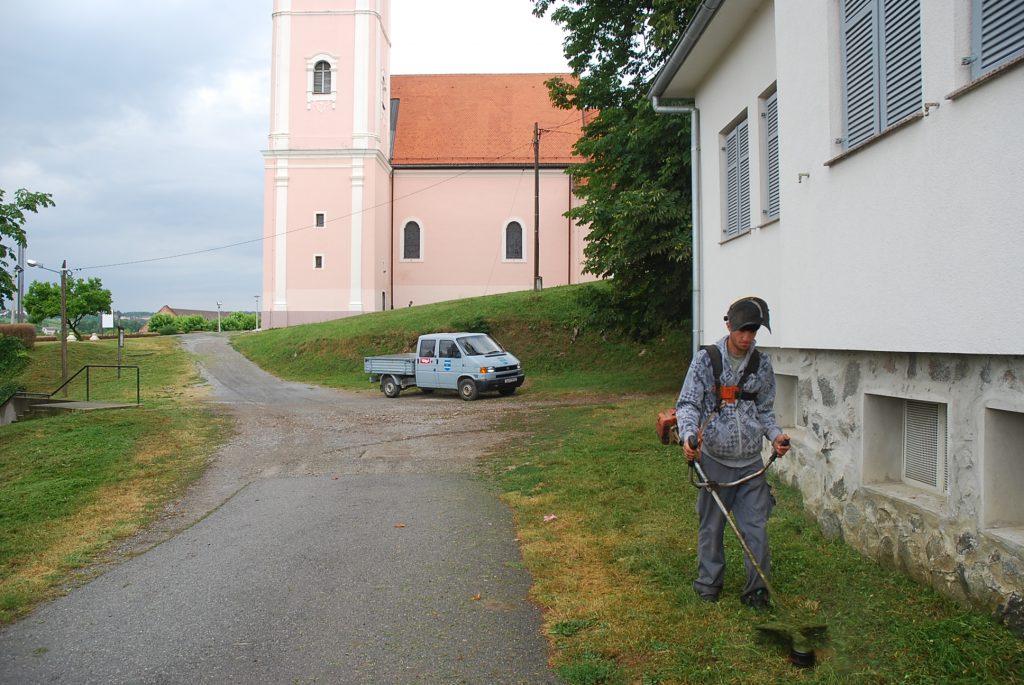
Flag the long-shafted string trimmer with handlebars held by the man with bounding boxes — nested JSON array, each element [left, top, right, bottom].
[[689, 435, 827, 668]]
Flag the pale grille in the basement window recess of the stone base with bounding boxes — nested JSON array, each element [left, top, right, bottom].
[[903, 399, 948, 495]]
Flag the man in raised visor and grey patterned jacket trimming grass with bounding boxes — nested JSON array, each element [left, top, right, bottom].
[[676, 297, 790, 610]]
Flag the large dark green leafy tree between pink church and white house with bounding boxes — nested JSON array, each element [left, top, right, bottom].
[[530, 0, 699, 338]]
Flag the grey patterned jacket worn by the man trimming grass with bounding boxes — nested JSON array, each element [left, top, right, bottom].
[[676, 336, 782, 467]]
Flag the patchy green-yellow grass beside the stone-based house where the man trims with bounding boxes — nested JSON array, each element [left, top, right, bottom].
[[488, 395, 1024, 684]]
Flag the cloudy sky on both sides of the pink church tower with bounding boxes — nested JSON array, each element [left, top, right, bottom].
[[0, 0, 567, 311]]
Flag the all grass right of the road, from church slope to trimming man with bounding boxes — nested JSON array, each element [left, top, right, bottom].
[[236, 288, 1024, 685]]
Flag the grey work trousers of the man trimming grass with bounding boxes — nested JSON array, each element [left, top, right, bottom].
[[693, 457, 772, 597]]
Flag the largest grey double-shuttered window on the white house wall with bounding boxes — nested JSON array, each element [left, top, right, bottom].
[[841, 0, 923, 148]]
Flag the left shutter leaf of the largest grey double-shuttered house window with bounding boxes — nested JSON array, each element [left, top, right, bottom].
[[841, 0, 882, 147]]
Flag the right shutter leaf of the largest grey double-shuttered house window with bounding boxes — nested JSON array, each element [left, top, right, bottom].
[[882, 0, 924, 129]]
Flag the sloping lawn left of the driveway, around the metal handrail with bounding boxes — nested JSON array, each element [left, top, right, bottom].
[[0, 338, 228, 624]]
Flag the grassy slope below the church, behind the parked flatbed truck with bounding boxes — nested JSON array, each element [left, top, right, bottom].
[[231, 284, 689, 396]]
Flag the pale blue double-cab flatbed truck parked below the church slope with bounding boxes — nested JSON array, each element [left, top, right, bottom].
[[362, 333, 526, 400]]
